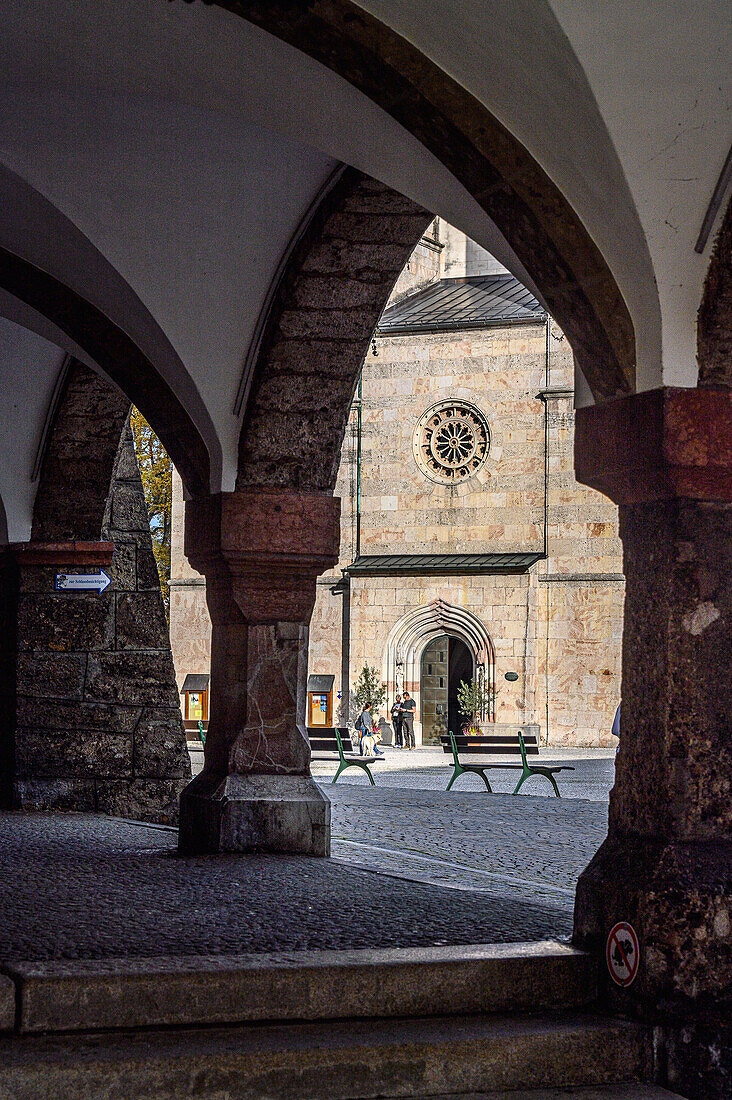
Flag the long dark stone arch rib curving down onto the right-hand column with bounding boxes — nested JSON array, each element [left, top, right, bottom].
[[216, 0, 635, 400]]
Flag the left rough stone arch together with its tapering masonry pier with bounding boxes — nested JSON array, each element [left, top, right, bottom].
[[11, 361, 190, 824]]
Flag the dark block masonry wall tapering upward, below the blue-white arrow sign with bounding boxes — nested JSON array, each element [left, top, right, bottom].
[[14, 429, 190, 823]]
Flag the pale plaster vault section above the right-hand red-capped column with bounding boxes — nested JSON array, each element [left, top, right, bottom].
[[356, 0, 732, 389]]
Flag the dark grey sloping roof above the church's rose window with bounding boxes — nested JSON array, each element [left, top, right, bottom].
[[379, 274, 546, 333]]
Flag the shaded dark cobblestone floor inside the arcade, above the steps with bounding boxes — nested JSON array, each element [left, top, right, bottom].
[[0, 814, 570, 963]]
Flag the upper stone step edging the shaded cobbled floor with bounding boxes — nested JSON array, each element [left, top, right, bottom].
[[4, 942, 597, 1033]]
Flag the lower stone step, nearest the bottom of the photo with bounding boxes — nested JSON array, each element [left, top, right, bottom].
[[0, 1013, 648, 1100]]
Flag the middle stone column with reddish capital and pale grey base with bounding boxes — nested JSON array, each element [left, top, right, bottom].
[[179, 487, 340, 856]]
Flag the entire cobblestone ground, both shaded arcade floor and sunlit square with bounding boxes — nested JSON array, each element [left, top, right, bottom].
[[0, 760, 612, 960]]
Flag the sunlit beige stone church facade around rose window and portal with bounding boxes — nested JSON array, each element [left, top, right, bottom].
[[310, 308, 623, 745]]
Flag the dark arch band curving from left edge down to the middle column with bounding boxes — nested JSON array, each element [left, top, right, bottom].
[[0, 164, 214, 495]]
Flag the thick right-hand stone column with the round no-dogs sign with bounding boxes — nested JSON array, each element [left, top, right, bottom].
[[575, 389, 732, 1097]]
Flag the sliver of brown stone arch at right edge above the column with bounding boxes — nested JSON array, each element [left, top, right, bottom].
[[697, 200, 732, 389]]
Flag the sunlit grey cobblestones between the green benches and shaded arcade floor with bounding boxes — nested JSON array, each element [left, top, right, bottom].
[[324, 783, 608, 914]]
